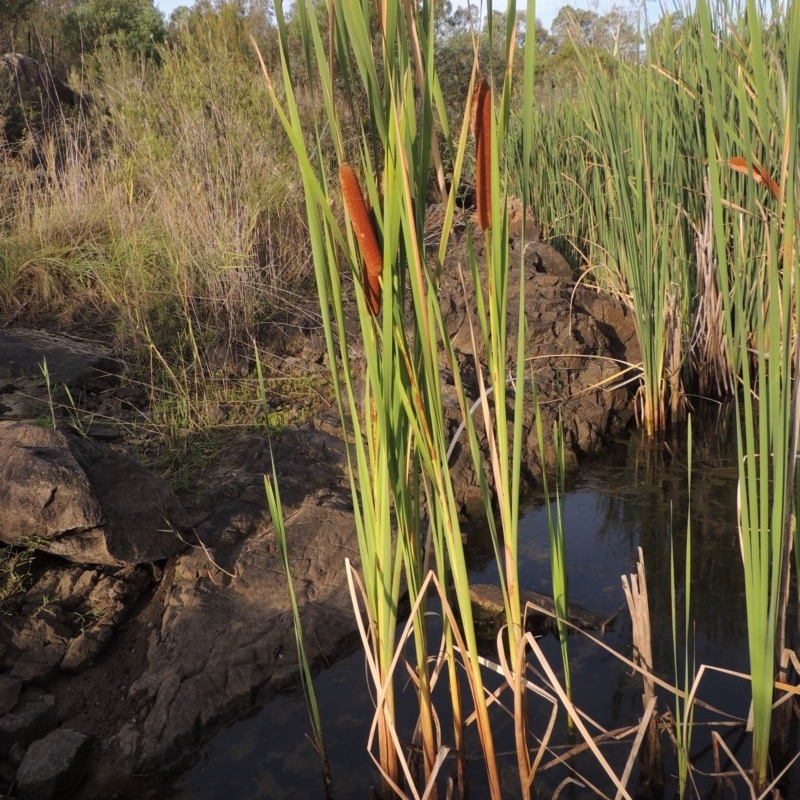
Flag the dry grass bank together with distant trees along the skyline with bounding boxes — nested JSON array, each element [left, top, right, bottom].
[[0, 0, 640, 428]]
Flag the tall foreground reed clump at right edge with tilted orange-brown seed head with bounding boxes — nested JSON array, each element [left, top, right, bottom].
[[697, 0, 800, 790]]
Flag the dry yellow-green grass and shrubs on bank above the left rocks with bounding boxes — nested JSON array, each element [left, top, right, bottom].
[[0, 1, 310, 438]]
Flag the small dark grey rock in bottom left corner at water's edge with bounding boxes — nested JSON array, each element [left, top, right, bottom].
[[17, 728, 91, 800]]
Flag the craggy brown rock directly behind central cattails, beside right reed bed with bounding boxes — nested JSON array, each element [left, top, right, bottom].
[[440, 240, 641, 517]]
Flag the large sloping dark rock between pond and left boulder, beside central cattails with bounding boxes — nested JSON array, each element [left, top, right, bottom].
[[127, 431, 358, 773]]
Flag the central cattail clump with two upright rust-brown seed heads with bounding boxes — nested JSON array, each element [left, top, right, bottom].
[[256, 0, 552, 797]]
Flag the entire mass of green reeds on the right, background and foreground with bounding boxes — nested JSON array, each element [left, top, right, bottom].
[[523, 2, 800, 788]]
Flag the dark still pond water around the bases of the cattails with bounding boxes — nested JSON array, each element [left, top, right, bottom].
[[164, 428, 791, 800]]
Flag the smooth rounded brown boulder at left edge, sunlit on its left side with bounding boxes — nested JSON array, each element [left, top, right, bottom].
[[0, 422, 187, 565]]
